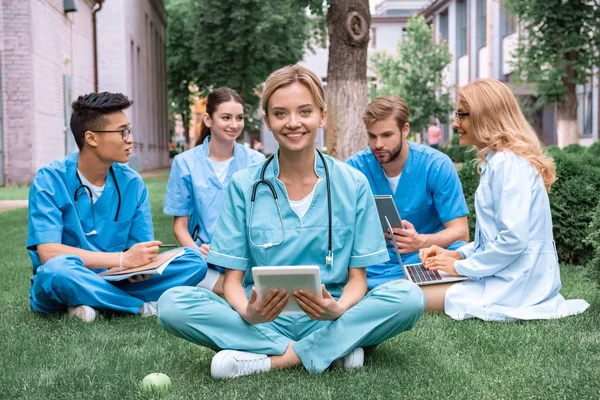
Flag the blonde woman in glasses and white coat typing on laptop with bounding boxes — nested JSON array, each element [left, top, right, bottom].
[[419, 79, 589, 321]]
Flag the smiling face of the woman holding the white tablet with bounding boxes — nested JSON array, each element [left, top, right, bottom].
[[265, 82, 327, 151]]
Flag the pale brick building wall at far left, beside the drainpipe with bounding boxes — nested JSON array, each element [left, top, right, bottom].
[[0, 0, 93, 183]]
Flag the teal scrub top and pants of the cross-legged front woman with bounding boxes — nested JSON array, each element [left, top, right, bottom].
[[158, 152, 424, 373]]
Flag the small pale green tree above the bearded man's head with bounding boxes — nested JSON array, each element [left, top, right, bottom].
[[371, 15, 453, 132]]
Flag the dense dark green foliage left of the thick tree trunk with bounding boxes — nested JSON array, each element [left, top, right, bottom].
[[167, 0, 314, 128]]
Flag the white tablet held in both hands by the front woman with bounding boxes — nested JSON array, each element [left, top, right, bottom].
[[252, 265, 323, 315]]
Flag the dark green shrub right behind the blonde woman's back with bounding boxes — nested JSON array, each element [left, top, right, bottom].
[[550, 151, 600, 264]]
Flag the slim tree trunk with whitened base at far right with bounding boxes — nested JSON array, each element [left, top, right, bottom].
[[556, 53, 579, 148]]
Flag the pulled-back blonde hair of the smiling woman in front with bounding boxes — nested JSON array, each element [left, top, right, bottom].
[[260, 65, 326, 115]]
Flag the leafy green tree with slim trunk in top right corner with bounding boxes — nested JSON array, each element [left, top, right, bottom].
[[506, 0, 600, 146]]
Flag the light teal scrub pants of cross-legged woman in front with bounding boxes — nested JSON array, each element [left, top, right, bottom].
[[158, 280, 425, 373]]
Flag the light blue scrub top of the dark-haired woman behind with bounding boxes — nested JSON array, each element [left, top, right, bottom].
[[163, 136, 265, 246]]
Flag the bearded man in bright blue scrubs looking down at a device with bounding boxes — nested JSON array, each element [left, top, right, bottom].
[[346, 96, 469, 289]]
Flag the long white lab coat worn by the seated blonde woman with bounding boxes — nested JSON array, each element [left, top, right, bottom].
[[445, 152, 589, 321]]
